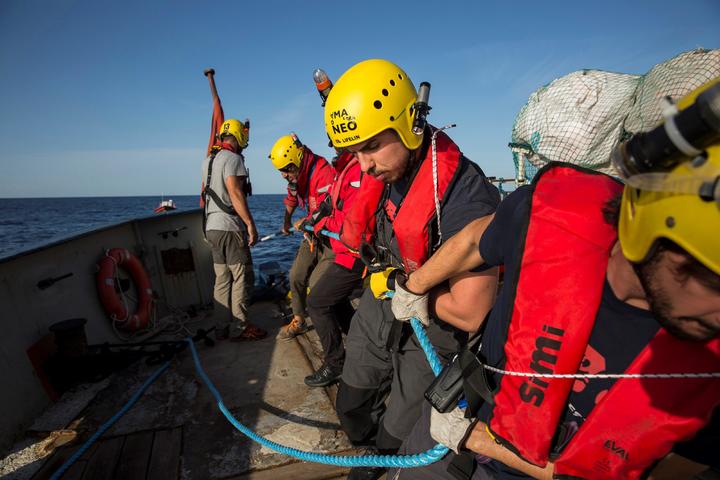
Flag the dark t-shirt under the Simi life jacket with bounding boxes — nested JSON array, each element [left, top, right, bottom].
[[479, 186, 717, 478]]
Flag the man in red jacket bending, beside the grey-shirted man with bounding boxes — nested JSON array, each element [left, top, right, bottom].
[[269, 133, 335, 340]]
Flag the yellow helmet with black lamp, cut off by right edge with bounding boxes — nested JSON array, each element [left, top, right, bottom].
[[618, 78, 720, 274]]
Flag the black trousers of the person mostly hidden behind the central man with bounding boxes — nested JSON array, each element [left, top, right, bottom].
[[307, 261, 364, 372]]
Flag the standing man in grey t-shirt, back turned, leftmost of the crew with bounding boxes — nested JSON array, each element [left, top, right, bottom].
[[202, 119, 267, 341]]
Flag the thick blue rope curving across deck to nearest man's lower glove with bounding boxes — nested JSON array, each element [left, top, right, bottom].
[[187, 340, 448, 468]]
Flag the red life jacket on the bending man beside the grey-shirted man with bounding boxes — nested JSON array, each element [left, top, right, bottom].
[[284, 147, 335, 218]]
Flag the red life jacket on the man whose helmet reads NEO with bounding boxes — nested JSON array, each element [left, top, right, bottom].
[[341, 128, 462, 272]]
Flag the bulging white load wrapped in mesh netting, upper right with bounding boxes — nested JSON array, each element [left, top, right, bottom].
[[510, 50, 720, 183]]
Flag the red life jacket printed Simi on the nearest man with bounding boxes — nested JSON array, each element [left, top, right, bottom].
[[488, 166, 720, 478]]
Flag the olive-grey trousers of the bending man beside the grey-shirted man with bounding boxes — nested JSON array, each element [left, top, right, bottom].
[[290, 239, 335, 317]]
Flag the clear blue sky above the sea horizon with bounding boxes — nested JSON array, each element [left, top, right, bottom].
[[0, 0, 720, 197]]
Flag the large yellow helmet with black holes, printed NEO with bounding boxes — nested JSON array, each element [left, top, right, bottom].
[[325, 59, 423, 150]]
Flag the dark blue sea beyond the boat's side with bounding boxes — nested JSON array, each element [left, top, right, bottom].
[[0, 195, 301, 269]]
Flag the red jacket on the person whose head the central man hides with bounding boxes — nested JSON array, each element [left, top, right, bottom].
[[315, 152, 362, 269]]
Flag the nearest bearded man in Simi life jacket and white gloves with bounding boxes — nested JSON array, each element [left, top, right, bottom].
[[393, 78, 720, 480]]
